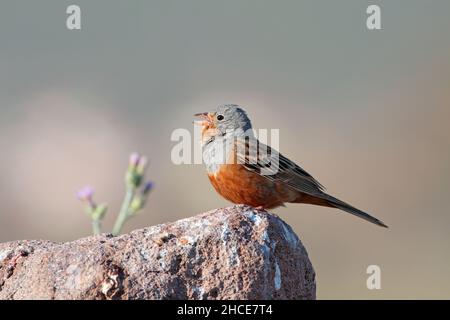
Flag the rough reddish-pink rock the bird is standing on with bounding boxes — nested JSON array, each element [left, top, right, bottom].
[[0, 205, 316, 299]]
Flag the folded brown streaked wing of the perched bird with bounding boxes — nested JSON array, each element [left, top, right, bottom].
[[236, 138, 325, 196]]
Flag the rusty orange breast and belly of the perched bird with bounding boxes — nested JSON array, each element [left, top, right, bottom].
[[208, 164, 297, 209]]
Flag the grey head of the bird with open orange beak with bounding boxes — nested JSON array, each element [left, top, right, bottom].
[[194, 104, 252, 137]]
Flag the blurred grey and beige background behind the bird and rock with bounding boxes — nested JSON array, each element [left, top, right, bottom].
[[0, 0, 450, 299]]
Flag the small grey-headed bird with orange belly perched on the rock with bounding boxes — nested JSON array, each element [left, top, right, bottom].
[[194, 104, 388, 228]]
